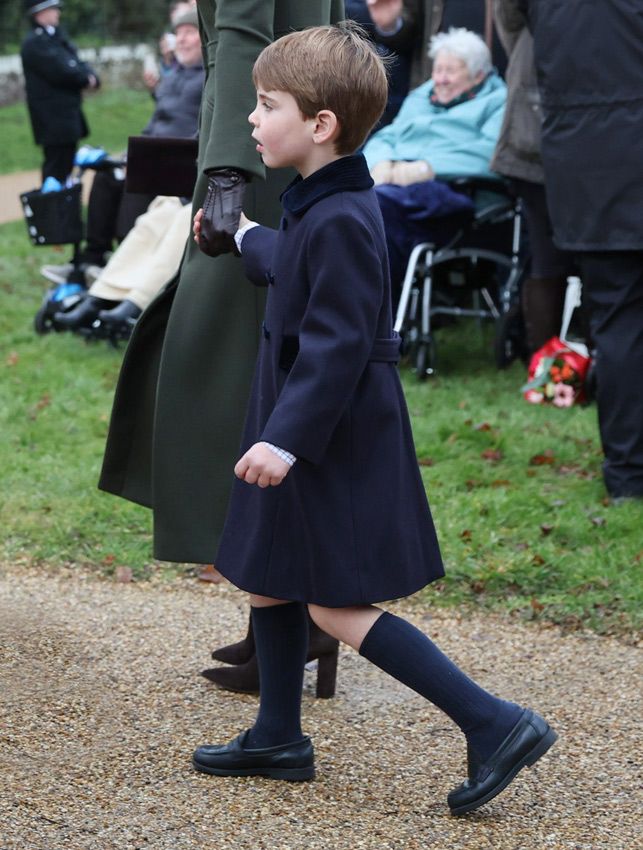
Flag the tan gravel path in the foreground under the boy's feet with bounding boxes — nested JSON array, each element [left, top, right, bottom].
[[0, 567, 643, 850]]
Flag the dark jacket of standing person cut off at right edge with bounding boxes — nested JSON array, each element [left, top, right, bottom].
[[528, 0, 643, 251]]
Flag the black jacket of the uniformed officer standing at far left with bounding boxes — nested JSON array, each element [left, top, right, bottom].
[[20, 27, 96, 145]]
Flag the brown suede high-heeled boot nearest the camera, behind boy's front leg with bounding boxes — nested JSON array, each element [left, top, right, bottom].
[[201, 617, 339, 699]]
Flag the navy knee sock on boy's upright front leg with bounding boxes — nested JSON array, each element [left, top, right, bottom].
[[246, 602, 308, 748]]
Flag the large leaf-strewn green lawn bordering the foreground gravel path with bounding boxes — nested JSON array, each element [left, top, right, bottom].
[[0, 215, 643, 634]]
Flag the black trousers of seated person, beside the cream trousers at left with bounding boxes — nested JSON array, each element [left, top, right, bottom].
[[81, 170, 154, 266]]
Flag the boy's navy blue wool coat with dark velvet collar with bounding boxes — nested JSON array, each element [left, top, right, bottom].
[[215, 155, 444, 607]]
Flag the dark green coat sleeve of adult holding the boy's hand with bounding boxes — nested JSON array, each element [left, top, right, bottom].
[[203, 0, 275, 178]]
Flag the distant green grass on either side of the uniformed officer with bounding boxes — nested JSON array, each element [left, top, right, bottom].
[[0, 89, 154, 174]]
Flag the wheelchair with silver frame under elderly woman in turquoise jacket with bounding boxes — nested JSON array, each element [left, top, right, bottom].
[[395, 177, 526, 380]]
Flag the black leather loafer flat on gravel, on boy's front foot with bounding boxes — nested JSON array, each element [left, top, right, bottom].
[[192, 730, 315, 782]]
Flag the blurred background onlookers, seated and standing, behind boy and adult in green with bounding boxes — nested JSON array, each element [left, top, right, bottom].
[[22, 0, 643, 497]]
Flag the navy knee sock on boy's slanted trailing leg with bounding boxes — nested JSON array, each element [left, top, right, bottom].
[[359, 611, 523, 761]]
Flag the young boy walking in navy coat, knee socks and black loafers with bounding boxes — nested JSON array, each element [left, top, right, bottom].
[[193, 25, 556, 814]]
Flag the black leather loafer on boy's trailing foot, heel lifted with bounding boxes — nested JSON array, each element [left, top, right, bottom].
[[447, 709, 558, 815]]
